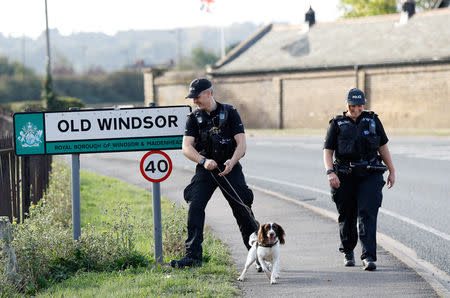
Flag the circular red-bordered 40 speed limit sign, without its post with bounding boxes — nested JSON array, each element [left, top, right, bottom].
[[139, 151, 172, 182]]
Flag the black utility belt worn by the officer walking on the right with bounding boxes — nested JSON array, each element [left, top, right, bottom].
[[334, 156, 388, 176]]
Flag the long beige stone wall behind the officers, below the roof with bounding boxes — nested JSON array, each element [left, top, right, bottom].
[[146, 64, 450, 129]]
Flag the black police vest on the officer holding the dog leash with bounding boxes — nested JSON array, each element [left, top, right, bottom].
[[193, 104, 236, 163]]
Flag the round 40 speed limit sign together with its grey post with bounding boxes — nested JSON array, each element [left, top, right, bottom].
[[140, 151, 172, 264]]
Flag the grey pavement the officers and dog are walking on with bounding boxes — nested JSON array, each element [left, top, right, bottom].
[[74, 155, 442, 297]]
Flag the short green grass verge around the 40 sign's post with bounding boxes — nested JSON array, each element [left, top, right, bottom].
[[37, 171, 241, 297]]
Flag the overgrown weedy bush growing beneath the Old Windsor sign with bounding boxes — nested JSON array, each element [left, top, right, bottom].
[[0, 163, 149, 294]]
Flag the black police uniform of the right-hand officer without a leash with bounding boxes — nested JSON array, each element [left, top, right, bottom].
[[324, 111, 388, 261]]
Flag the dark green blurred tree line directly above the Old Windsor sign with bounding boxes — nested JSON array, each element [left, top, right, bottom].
[[0, 57, 144, 106]]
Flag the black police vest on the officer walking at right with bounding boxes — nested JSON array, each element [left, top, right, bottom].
[[333, 111, 380, 161]]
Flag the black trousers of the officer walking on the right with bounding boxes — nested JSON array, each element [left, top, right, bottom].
[[331, 173, 385, 261]]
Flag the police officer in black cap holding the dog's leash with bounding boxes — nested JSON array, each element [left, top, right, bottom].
[[170, 78, 258, 268]]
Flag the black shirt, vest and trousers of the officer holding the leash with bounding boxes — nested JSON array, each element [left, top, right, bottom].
[[184, 102, 258, 260]]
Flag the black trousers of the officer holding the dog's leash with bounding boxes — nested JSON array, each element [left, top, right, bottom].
[[184, 163, 258, 260]]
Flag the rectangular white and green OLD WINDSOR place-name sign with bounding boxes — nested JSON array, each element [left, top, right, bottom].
[[13, 106, 191, 155]]
